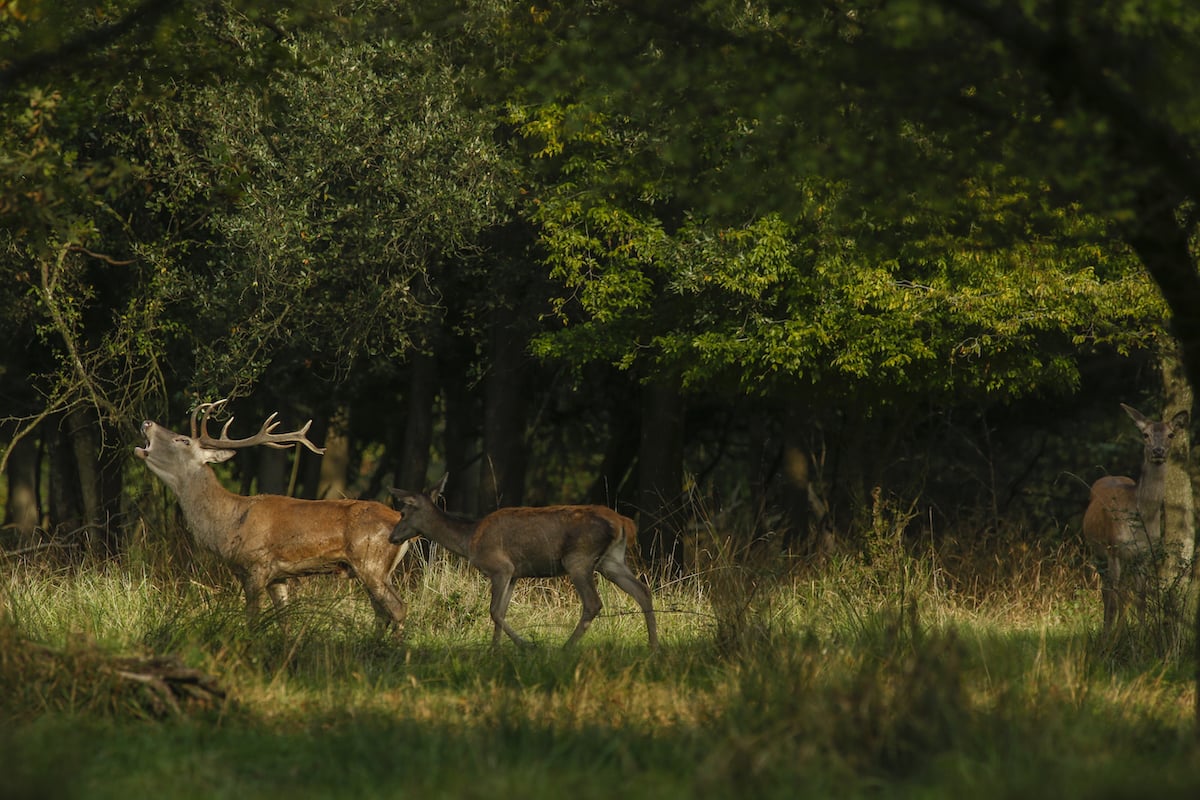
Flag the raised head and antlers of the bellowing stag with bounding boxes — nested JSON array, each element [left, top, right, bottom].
[[133, 399, 325, 491]]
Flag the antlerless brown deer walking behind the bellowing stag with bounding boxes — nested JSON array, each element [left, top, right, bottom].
[[390, 489, 659, 650]]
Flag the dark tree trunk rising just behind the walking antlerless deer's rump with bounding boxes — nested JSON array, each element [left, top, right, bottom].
[[637, 377, 684, 569]]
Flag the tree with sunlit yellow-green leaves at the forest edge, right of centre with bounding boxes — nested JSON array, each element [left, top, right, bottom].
[[504, 56, 1162, 561]]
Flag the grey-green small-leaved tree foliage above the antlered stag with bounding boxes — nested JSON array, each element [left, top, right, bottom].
[[112, 5, 520, 386]]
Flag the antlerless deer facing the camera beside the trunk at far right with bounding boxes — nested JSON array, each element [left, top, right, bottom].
[[1084, 403, 1188, 636]]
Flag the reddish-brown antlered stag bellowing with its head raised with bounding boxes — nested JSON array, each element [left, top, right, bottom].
[[133, 399, 408, 631]]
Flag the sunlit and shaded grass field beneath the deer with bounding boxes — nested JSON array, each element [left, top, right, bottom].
[[0, 537, 1200, 800]]
